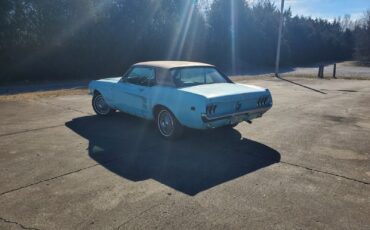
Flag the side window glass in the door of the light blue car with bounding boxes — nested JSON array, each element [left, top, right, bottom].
[[126, 67, 155, 86]]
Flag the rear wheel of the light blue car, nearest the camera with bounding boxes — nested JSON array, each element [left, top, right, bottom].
[[156, 107, 184, 140]]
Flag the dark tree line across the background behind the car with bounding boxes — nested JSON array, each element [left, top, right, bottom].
[[0, 0, 370, 82]]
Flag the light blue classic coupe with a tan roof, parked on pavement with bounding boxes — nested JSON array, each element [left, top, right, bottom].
[[89, 61, 272, 139]]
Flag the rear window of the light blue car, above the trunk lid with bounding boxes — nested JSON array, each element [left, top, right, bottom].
[[171, 67, 230, 88]]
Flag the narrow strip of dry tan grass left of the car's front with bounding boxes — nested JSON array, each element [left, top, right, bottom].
[[0, 89, 88, 101]]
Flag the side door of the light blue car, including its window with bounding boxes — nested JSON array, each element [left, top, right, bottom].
[[113, 66, 155, 117]]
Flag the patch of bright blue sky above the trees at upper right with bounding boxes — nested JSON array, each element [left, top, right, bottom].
[[268, 0, 370, 20]]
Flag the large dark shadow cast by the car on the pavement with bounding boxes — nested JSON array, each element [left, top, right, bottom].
[[66, 113, 280, 196]]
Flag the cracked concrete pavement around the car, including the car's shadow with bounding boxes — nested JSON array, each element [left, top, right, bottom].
[[0, 78, 370, 229]]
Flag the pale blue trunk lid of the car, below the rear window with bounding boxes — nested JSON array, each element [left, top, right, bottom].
[[179, 83, 268, 99]]
